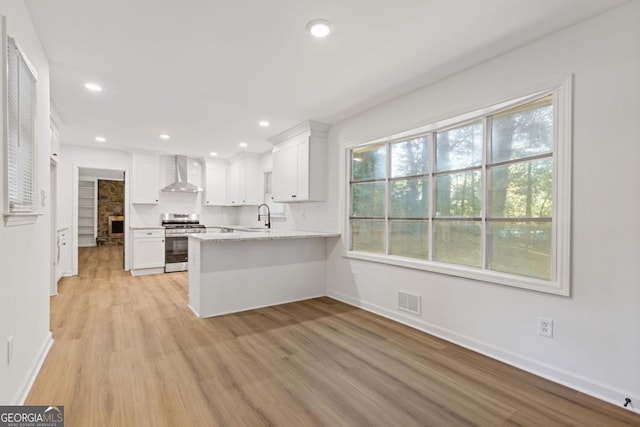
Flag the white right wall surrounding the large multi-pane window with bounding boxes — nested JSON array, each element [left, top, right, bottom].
[[324, 1, 640, 410]]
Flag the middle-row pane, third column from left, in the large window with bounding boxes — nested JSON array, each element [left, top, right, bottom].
[[436, 171, 482, 217]]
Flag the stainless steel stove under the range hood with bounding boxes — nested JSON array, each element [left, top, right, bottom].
[[160, 213, 207, 273]]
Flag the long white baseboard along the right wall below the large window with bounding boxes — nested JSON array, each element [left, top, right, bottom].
[[327, 291, 640, 414]]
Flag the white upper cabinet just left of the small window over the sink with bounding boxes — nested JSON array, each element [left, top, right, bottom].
[[227, 153, 262, 206]]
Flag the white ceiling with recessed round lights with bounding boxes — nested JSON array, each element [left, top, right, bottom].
[[25, 0, 628, 158]]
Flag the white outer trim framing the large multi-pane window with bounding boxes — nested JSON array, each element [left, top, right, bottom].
[[343, 75, 573, 296]]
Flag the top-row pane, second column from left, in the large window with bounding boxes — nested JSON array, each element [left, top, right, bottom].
[[391, 136, 430, 178]]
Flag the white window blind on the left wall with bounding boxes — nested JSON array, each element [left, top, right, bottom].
[[7, 37, 36, 213]]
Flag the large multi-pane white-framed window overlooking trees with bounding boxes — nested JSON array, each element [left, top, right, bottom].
[[348, 86, 570, 295]]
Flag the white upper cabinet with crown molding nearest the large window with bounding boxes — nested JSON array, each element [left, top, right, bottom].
[[269, 120, 330, 202]]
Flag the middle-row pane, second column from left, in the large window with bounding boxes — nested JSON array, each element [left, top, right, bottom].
[[390, 178, 429, 218]]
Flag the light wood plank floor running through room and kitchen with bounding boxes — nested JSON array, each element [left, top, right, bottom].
[[26, 247, 640, 427]]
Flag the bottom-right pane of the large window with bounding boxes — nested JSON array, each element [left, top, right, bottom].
[[488, 221, 552, 280]]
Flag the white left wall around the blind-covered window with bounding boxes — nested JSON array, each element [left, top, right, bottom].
[[0, 0, 52, 404]]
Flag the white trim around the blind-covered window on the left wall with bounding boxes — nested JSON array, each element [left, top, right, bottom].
[[0, 24, 43, 227]]
